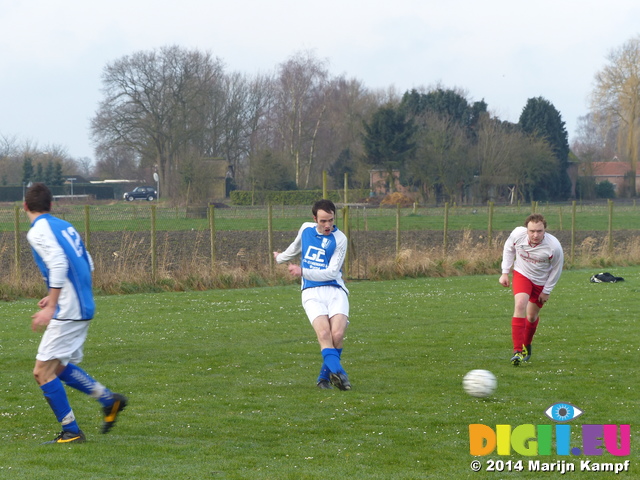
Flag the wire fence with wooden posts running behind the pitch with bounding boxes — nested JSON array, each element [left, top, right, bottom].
[[0, 202, 640, 284]]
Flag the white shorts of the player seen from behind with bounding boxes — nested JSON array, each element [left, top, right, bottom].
[[36, 320, 91, 365]]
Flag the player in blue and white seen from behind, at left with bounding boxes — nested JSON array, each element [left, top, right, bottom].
[[24, 183, 127, 443]]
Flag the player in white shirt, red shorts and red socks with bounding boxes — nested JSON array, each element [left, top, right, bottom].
[[498, 213, 564, 366]]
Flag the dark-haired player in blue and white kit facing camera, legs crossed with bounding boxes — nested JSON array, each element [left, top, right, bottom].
[[273, 200, 351, 390]]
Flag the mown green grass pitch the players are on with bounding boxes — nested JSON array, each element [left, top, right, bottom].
[[0, 267, 640, 480]]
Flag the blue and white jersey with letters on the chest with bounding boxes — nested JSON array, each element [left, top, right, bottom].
[[276, 222, 349, 293]]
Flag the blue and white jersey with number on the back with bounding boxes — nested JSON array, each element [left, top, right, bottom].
[[27, 213, 95, 320]]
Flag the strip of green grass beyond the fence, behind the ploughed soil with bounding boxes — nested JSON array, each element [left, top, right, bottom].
[[0, 202, 640, 232]]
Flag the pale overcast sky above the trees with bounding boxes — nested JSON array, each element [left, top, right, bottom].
[[0, 0, 640, 159]]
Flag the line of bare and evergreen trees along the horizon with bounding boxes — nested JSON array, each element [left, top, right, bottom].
[[0, 39, 640, 203]]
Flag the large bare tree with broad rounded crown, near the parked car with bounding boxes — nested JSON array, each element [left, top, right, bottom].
[[91, 46, 223, 196]]
